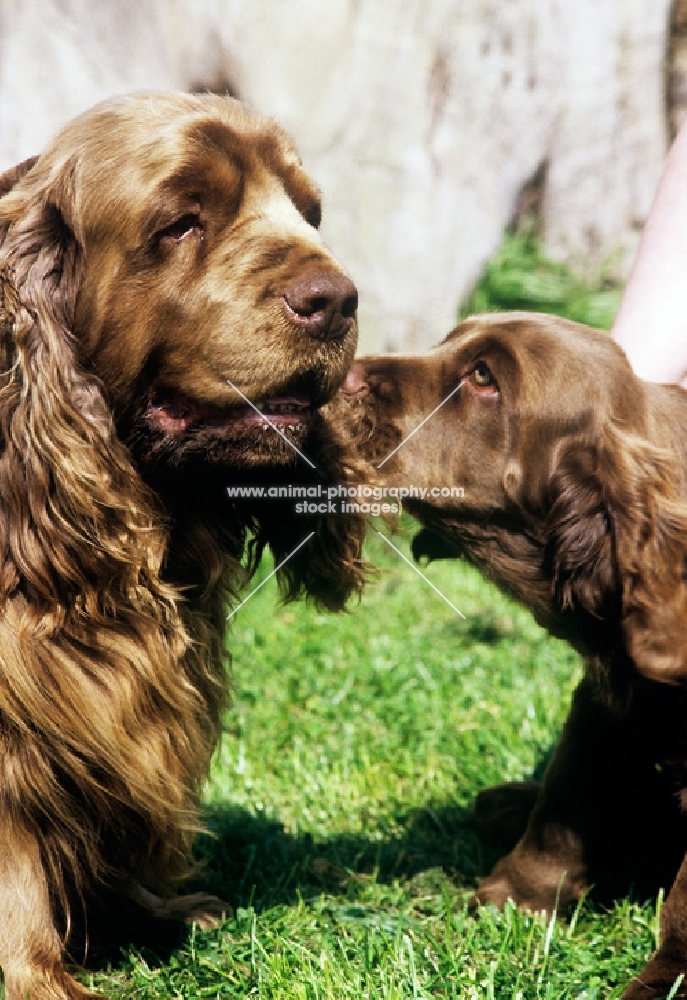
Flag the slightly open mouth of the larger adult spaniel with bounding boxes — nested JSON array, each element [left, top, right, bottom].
[[147, 389, 312, 434]]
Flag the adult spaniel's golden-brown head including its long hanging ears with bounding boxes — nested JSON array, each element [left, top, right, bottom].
[[0, 93, 360, 606]]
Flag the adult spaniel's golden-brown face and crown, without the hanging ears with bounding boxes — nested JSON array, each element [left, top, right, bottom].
[[0, 94, 357, 468]]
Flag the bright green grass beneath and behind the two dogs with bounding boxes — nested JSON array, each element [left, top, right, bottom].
[[85, 235, 660, 1000]]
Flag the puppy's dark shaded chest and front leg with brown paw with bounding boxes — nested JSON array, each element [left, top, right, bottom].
[[475, 679, 682, 912]]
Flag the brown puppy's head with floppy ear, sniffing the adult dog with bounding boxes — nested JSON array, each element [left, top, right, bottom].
[[344, 313, 687, 681]]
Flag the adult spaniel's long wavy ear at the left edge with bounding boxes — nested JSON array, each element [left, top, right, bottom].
[[0, 162, 169, 626]]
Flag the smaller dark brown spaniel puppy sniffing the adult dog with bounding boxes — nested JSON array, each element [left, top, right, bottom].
[[345, 313, 687, 1000]]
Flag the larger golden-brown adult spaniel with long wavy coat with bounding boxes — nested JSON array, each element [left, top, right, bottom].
[[0, 94, 362, 1000]]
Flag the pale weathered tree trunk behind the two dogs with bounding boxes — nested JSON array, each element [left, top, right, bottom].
[[0, 0, 676, 350]]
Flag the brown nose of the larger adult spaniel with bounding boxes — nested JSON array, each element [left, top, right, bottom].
[[283, 272, 358, 340]]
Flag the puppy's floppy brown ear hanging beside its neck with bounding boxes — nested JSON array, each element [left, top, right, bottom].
[[547, 425, 687, 683]]
